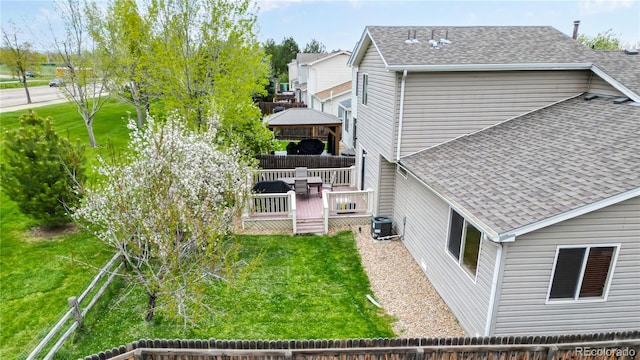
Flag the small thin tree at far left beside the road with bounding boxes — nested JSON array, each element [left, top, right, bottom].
[[0, 22, 36, 104]]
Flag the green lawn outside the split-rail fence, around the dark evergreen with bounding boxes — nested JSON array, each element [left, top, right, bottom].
[[0, 101, 135, 359]]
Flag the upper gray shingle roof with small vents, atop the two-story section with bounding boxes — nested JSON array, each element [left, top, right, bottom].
[[367, 26, 594, 66]]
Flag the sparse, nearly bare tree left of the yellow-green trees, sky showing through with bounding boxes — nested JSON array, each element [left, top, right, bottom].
[[51, 0, 110, 147]]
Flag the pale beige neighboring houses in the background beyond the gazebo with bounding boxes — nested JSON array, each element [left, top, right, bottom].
[[288, 51, 351, 116]]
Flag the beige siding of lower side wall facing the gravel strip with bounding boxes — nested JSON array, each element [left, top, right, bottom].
[[393, 174, 497, 336]]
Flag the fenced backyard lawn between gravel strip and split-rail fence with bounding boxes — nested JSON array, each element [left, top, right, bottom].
[[64, 232, 394, 358]]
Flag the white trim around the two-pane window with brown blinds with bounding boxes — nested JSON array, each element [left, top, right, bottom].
[[545, 243, 620, 304]]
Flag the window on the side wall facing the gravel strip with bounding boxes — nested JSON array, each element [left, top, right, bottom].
[[447, 209, 482, 276]]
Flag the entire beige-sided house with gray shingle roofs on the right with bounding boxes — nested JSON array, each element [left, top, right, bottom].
[[345, 27, 640, 336]]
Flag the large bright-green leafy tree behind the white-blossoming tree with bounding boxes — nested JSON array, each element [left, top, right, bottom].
[[146, 0, 270, 150]]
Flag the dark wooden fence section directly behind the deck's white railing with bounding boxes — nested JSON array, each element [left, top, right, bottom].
[[256, 155, 356, 169]]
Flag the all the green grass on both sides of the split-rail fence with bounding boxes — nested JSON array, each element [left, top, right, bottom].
[[0, 101, 394, 359]]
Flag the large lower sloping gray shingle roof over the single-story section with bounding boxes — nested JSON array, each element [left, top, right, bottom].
[[400, 97, 640, 234]]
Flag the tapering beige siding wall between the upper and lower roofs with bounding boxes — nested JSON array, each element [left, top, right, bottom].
[[394, 71, 590, 156]]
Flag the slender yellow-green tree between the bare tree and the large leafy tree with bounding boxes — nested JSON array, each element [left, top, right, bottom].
[[87, 0, 157, 126]]
